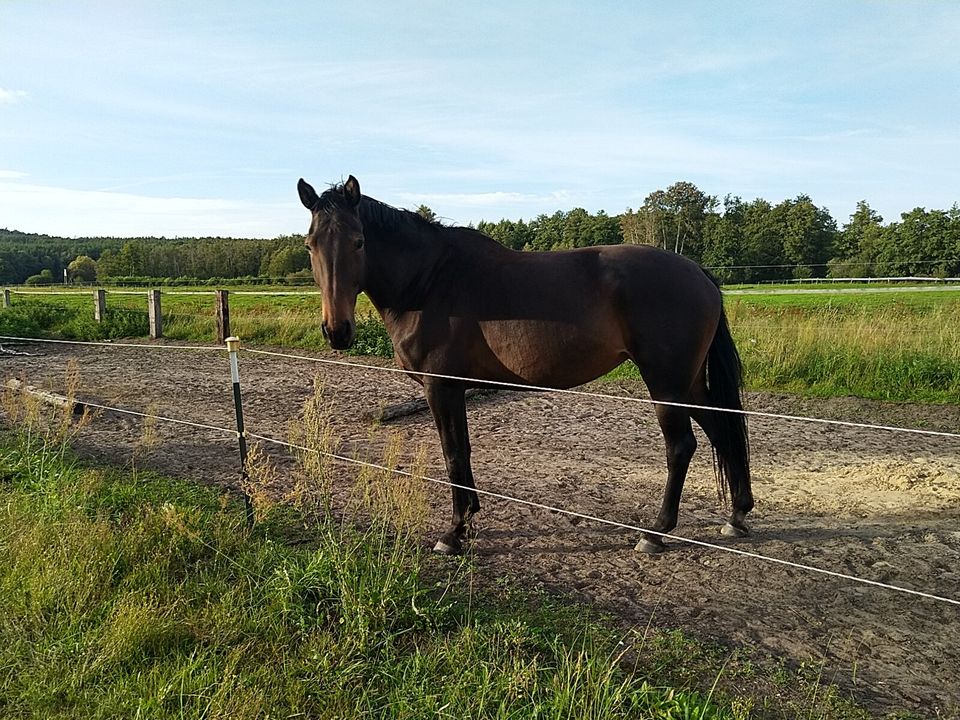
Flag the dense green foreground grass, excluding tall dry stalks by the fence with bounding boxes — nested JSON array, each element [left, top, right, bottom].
[[0, 436, 732, 718]]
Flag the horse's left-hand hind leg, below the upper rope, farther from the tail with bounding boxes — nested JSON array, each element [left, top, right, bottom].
[[636, 397, 697, 554]]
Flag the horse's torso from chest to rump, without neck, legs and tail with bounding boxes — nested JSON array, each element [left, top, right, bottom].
[[397, 240, 719, 387]]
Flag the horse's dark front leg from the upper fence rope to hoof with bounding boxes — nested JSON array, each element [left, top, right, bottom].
[[424, 379, 480, 555]]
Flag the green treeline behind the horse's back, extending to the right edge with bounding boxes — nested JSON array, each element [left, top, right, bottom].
[[478, 182, 960, 283]]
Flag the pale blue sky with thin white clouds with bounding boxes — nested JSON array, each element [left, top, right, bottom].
[[0, 0, 960, 237]]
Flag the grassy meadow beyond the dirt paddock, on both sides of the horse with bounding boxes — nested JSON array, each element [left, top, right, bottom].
[[0, 285, 960, 403]]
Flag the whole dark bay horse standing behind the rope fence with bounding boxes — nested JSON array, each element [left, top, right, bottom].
[[297, 175, 753, 554]]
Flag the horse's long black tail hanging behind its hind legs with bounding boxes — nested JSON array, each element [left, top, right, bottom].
[[707, 308, 750, 498]]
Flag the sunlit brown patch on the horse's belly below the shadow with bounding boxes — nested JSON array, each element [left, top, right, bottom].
[[481, 320, 627, 387]]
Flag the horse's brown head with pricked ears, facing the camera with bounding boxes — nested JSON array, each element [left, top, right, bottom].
[[297, 175, 366, 350]]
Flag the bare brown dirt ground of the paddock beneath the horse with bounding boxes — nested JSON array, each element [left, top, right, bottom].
[[0, 344, 960, 717]]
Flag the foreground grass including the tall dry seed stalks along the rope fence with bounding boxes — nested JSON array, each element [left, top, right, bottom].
[[0, 380, 880, 720]]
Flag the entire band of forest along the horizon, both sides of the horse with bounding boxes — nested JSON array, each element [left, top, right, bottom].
[[0, 182, 960, 284]]
